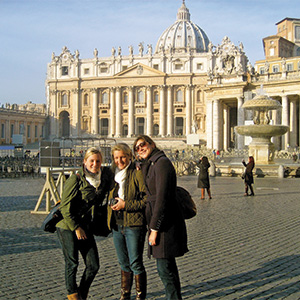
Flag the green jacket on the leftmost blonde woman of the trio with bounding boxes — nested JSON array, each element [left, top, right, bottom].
[[56, 167, 113, 231]]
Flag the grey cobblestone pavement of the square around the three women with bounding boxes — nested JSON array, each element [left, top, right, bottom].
[[0, 176, 300, 300]]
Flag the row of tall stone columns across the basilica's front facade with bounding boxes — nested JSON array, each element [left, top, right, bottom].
[[50, 85, 194, 137]]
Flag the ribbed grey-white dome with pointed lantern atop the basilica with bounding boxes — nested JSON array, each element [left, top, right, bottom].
[[155, 0, 209, 53]]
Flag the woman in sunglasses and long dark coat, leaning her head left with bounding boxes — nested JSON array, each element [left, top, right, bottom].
[[133, 135, 188, 300]]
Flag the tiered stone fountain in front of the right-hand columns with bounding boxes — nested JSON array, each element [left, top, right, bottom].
[[235, 88, 289, 164]]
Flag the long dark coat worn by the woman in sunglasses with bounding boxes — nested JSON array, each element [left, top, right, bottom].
[[142, 149, 188, 258]]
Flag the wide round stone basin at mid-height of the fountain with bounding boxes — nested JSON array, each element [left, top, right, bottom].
[[235, 125, 289, 138]]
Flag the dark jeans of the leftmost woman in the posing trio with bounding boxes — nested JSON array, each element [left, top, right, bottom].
[[57, 228, 99, 299]]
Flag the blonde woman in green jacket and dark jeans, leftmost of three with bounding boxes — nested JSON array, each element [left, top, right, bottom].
[[56, 147, 113, 300]]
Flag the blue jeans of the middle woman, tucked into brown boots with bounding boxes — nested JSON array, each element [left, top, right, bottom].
[[112, 225, 146, 275]]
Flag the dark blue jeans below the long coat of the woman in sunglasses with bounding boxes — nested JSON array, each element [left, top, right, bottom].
[[156, 258, 182, 300]]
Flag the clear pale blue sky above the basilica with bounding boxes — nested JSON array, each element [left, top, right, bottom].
[[0, 0, 300, 105]]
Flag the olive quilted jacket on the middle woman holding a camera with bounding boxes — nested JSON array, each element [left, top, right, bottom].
[[107, 163, 146, 229]]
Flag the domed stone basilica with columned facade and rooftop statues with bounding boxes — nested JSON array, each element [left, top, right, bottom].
[[46, 1, 299, 150]]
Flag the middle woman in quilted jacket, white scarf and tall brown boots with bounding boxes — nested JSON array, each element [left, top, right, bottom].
[[108, 143, 147, 300]]
